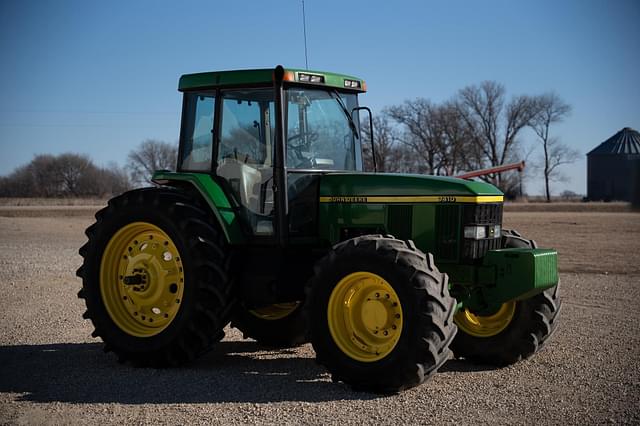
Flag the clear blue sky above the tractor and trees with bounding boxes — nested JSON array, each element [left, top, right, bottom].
[[0, 0, 640, 193]]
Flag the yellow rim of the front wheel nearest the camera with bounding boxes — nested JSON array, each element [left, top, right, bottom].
[[327, 272, 403, 362]]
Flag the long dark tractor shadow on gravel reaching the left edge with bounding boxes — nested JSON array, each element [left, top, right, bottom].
[[0, 341, 380, 404]]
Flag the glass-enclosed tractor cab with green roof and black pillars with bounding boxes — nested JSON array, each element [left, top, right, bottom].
[[178, 67, 364, 239]]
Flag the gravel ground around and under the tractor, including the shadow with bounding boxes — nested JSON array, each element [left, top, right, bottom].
[[0, 213, 640, 424]]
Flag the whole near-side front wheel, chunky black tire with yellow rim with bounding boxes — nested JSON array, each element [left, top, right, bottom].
[[307, 235, 456, 393]]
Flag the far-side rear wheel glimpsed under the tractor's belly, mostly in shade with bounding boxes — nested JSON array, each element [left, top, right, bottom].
[[231, 302, 306, 348]]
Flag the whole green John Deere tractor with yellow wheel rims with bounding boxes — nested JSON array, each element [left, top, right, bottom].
[[77, 66, 560, 393]]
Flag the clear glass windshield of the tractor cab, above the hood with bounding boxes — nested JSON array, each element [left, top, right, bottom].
[[285, 87, 362, 170]]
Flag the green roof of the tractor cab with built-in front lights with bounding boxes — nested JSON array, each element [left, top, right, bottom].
[[178, 68, 367, 93]]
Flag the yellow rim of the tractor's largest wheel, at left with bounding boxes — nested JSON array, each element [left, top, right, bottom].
[[100, 222, 184, 337]]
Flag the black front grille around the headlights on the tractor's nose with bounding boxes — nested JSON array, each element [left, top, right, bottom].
[[461, 203, 502, 261]]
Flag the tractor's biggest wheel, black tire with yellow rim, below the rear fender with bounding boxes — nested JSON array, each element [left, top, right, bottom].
[[77, 188, 233, 367]]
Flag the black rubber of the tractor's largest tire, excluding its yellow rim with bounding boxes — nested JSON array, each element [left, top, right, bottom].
[[76, 187, 234, 367]]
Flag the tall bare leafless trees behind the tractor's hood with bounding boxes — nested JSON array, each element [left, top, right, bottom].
[[363, 81, 578, 200]]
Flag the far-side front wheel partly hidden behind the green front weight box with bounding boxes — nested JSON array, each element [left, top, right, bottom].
[[451, 230, 561, 366]]
